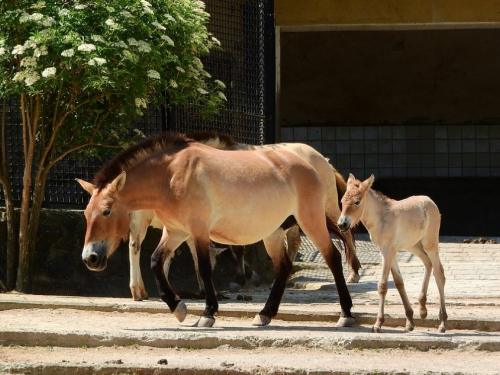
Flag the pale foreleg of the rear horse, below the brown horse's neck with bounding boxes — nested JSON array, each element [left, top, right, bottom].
[[128, 212, 151, 301]]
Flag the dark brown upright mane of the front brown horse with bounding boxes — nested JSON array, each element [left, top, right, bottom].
[[93, 132, 194, 189]]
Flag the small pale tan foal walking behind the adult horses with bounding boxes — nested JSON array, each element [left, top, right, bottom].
[[338, 174, 448, 333]]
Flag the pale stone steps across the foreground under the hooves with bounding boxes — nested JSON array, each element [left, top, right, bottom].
[[0, 296, 500, 375]]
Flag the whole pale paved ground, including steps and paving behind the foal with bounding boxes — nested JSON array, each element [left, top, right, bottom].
[[0, 237, 500, 375]]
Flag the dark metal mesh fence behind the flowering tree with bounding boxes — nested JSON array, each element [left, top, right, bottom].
[[0, 0, 275, 208]]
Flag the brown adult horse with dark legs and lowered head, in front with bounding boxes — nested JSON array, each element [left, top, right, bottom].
[[79, 133, 354, 327]]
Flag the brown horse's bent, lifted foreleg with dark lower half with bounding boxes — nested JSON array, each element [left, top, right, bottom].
[[151, 228, 187, 322]]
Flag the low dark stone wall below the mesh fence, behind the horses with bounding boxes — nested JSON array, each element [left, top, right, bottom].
[[0, 209, 273, 297]]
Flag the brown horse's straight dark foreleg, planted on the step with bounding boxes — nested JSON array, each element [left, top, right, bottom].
[[193, 236, 219, 327]]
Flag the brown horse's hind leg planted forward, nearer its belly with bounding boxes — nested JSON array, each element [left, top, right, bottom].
[[252, 229, 292, 326]]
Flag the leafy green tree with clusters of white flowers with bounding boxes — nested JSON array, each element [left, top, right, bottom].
[[0, 0, 225, 292]]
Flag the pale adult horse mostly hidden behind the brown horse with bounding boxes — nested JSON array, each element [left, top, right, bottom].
[[124, 132, 361, 300]]
